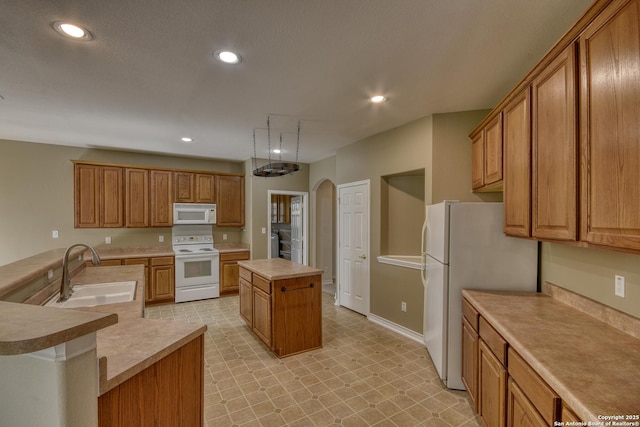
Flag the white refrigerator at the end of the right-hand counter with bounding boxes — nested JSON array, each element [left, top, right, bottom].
[[423, 201, 538, 390]]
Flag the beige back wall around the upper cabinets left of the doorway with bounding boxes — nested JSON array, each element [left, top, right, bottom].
[[0, 140, 243, 265]]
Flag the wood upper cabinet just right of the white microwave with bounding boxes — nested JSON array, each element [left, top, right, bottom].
[[216, 175, 244, 227]]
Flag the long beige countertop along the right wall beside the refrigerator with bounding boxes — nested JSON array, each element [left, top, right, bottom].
[[462, 290, 640, 422]]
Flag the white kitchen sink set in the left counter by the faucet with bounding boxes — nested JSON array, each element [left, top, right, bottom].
[[44, 281, 136, 308]]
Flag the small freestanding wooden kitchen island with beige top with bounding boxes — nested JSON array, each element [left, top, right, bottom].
[[238, 258, 322, 357]]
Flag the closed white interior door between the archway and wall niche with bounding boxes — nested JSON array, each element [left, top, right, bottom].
[[338, 181, 369, 316]]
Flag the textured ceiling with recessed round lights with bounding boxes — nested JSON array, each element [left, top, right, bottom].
[[0, 0, 591, 162]]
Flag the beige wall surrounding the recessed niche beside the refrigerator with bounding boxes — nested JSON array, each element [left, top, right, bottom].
[[335, 111, 490, 333]]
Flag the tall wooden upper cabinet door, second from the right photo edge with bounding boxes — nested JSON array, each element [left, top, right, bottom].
[[531, 45, 578, 244]]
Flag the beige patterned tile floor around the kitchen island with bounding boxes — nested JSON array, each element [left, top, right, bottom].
[[147, 293, 479, 427]]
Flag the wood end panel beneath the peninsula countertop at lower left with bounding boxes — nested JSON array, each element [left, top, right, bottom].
[[98, 335, 204, 427]]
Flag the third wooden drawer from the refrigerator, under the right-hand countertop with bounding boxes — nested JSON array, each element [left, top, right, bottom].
[[508, 348, 560, 425]]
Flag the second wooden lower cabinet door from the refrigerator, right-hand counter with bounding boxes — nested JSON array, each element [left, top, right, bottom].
[[478, 339, 507, 427]]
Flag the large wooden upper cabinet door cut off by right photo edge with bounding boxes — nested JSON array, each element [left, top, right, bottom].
[[580, 0, 640, 249]]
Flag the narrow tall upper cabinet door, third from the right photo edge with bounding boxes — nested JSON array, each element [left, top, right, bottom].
[[503, 88, 531, 237]]
